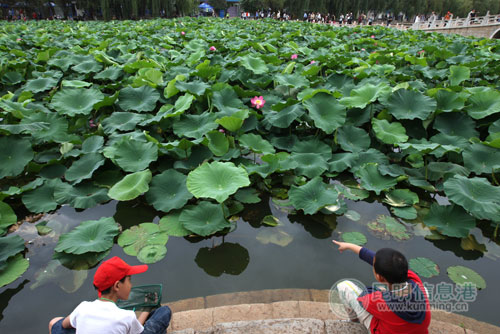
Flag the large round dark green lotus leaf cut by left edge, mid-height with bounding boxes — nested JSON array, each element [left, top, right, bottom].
[[0, 136, 34, 179]]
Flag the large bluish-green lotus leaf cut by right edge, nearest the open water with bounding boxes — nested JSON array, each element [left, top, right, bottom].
[[443, 175, 500, 222]]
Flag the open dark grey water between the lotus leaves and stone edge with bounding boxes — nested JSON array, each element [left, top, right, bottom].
[[0, 197, 500, 334]]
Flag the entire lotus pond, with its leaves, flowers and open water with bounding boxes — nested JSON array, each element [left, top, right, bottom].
[[0, 19, 500, 333]]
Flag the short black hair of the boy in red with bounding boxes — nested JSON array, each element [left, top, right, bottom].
[[373, 248, 408, 284]]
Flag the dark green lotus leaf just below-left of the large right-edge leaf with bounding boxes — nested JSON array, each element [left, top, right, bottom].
[[424, 203, 476, 238]]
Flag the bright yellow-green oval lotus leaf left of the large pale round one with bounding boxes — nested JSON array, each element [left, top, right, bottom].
[[108, 169, 152, 201]]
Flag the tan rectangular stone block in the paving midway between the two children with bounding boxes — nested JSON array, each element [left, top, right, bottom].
[[213, 304, 273, 324]]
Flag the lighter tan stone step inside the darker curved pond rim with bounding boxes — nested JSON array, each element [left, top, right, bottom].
[[168, 301, 478, 334]]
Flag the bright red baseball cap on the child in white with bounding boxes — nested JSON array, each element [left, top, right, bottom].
[[94, 256, 148, 296]]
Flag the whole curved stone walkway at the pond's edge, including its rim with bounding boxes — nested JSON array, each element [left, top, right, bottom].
[[164, 289, 500, 334]]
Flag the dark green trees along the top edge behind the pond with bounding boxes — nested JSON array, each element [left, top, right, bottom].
[[3, 0, 500, 19]]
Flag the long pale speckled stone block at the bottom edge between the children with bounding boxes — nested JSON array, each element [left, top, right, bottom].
[[214, 319, 325, 334]]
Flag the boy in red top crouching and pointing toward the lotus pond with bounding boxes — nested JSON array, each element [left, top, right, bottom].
[[333, 240, 431, 334]]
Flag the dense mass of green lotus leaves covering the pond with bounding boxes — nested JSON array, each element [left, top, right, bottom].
[[0, 19, 500, 274]]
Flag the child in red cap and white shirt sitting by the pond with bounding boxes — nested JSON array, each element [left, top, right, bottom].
[[49, 256, 172, 334]]
